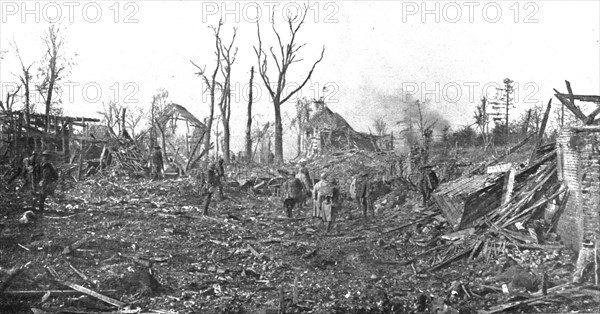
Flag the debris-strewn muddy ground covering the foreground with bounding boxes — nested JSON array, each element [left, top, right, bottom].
[[0, 173, 600, 313]]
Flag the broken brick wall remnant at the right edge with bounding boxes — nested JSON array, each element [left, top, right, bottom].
[[557, 129, 600, 251]]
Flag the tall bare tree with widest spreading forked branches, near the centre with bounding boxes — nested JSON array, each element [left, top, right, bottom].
[[254, 5, 325, 163]]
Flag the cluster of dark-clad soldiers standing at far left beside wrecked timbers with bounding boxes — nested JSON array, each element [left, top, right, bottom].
[[20, 150, 59, 213]]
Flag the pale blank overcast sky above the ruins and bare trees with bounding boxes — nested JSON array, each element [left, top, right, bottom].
[[0, 1, 600, 155]]
